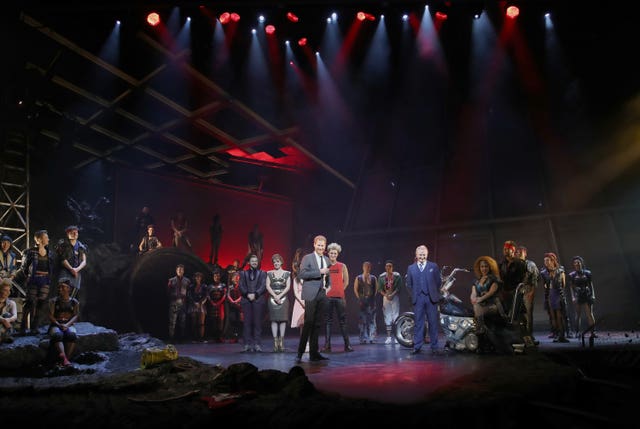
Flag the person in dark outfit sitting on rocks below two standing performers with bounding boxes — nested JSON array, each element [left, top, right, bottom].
[[49, 280, 80, 366]]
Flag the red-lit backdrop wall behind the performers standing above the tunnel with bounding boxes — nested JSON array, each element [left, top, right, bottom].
[[114, 168, 293, 270]]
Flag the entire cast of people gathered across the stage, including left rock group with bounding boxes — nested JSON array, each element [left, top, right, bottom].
[[0, 225, 595, 365]]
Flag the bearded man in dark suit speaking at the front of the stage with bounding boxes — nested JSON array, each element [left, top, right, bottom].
[[296, 235, 331, 363]]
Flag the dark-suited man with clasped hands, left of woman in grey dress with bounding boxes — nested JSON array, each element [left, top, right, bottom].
[[238, 255, 267, 352]]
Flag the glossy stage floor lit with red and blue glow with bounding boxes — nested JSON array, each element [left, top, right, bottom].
[[176, 331, 640, 404]]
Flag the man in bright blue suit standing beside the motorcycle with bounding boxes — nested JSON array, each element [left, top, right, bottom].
[[406, 245, 442, 354]]
